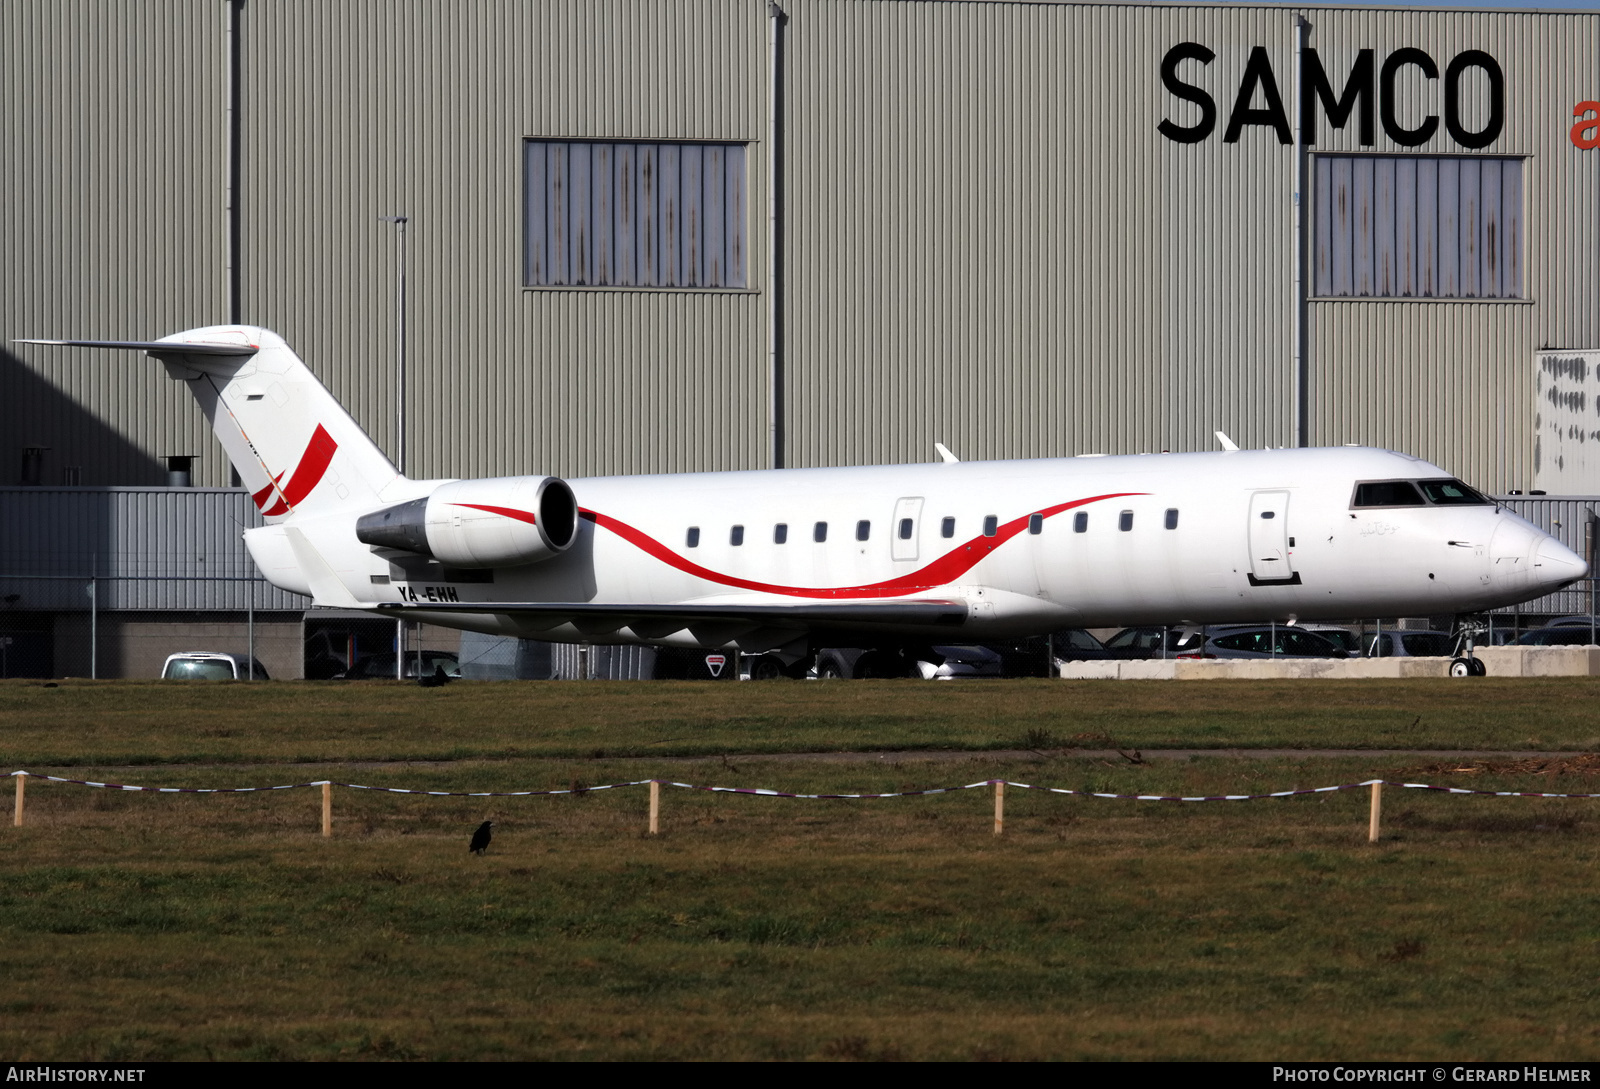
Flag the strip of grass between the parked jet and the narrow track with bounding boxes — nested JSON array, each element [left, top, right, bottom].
[[0, 676, 1600, 766]]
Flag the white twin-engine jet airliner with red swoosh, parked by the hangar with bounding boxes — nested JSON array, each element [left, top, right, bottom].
[[15, 326, 1587, 673]]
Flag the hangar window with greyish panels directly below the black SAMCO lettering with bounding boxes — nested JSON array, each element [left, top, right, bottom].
[[1312, 155, 1523, 299]]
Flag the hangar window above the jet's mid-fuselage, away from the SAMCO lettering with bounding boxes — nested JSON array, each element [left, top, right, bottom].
[[523, 139, 747, 289]]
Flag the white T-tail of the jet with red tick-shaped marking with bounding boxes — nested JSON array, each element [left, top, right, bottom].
[[22, 325, 403, 523]]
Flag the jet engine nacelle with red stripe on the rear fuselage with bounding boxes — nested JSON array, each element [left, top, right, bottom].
[[355, 477, 578, 568]]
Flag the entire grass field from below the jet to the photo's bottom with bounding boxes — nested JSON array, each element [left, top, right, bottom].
[[0, 680, 1600, 1060]]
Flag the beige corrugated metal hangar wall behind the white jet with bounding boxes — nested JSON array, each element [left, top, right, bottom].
[[0, 0, 1600, 489]]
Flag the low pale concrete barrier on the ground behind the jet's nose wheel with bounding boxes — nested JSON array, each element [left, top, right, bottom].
[[1061, 646, 1600, 681]]
